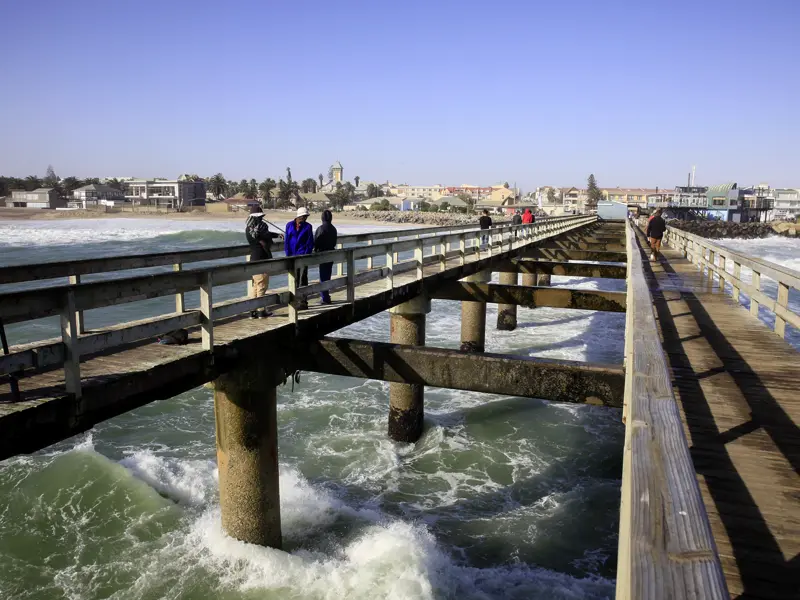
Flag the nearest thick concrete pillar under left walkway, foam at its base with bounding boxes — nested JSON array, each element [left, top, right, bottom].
[[214, 363, 282, 548]]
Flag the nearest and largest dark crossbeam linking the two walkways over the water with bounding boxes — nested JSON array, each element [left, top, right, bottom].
[[291, 338, 625, 407]]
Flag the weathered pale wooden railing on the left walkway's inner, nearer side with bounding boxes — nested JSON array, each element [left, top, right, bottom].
[[0, 216, 596, 397]]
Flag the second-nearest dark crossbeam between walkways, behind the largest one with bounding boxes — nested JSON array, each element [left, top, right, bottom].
[[431, 282, 625, 312]]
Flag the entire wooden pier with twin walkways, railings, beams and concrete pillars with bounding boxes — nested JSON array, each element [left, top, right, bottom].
[[0, 216, 800, 600]]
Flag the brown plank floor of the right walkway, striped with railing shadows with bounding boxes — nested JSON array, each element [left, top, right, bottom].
[[642, 232, 800, 600]]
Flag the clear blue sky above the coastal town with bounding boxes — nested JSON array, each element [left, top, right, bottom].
[[0, 0, 800, 190]]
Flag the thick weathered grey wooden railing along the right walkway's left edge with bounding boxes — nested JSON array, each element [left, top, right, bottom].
[[616, 223, 729, 600]]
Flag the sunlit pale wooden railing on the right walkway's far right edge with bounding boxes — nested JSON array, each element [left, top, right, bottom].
[[664, 227, 800, 337]]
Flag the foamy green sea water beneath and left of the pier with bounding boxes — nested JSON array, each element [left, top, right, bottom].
[[0, 219, 664, 600]]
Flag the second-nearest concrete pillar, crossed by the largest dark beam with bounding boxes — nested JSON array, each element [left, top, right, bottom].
[[389, 295, 431, 442]]
